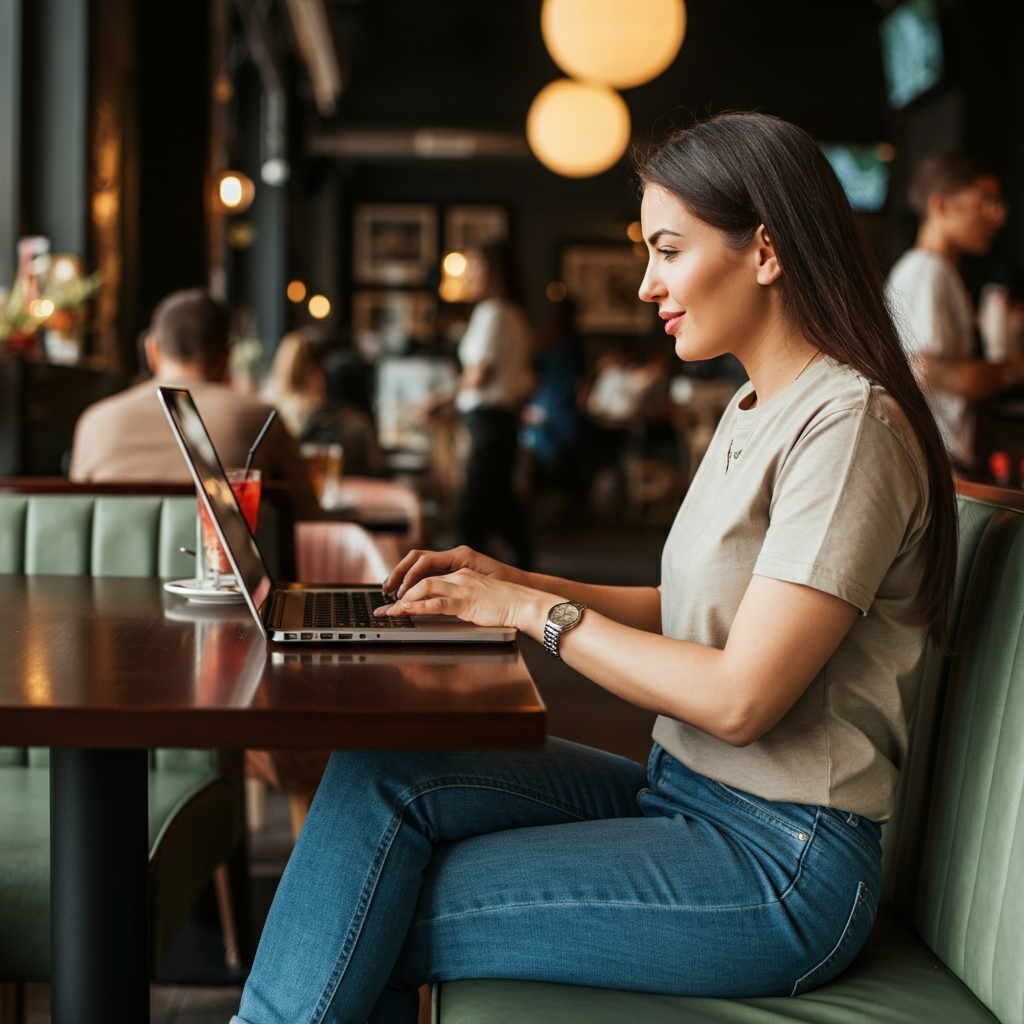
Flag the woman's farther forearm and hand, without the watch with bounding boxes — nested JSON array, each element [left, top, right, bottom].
[[384, 546, 662, 633]]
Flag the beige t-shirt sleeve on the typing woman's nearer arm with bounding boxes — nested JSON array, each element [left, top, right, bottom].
[[754, 409, 921, 613]]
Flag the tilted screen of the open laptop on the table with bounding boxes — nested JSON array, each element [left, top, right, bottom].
[[157, 387, 271, 633]]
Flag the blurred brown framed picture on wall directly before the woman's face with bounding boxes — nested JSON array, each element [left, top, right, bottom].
[[562, 244, 654, 334]]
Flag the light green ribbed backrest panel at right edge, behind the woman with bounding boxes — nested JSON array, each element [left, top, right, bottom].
[[913, 511, 1024, 1024]]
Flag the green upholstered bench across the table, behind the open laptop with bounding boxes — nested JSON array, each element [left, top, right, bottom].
[[0, 487, 260, 982]]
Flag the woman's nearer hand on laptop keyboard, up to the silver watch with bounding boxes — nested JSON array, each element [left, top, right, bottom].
[[375, 569, 563, 639]]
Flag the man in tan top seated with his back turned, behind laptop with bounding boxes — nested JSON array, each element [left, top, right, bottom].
[[69, 289, 322, 519]]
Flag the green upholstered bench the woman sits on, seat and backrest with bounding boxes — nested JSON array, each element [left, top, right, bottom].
[[433, 496, 1024, 1024]]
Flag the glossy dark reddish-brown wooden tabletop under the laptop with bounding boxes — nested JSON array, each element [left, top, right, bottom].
[[0, 577, 545, 746]]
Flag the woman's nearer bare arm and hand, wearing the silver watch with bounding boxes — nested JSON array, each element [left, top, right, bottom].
[[380, 568, 858, 746]]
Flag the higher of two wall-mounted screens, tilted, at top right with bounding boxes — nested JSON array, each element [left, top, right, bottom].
[[880, 0, 944, 110]]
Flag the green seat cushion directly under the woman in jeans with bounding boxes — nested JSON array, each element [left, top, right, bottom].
[[434, 904, 997, 1024]]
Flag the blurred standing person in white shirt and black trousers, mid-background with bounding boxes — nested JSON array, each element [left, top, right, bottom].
[[455, 245, 532, 568]]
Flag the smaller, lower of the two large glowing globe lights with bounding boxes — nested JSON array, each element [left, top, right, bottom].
[[526, 78, 630, 178]]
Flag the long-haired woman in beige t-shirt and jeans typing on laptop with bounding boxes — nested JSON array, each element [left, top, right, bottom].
[[230, 114, 955, 1024]]
